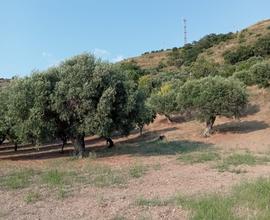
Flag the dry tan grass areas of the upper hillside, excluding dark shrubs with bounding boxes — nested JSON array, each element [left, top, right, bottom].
[[124, 19, 270, 71]]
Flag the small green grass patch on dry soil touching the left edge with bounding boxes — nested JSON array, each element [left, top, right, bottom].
[[0, 169, 34, 190]]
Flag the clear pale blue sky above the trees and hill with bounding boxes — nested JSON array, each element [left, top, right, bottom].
[[0, 0, 270, 78]]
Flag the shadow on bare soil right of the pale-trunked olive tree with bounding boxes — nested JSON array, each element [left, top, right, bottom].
[[215, 120, 269, 134]]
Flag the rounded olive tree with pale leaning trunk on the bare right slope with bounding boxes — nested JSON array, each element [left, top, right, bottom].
[[177, 76, 248, 136]]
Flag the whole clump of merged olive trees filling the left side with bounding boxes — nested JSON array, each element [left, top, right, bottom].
[[0, 54, 152, 155]]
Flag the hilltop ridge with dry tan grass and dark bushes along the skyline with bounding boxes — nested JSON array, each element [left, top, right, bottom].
[[123, 19, 270, 71]]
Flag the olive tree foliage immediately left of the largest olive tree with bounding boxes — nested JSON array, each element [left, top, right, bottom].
[[7, 72, 60, 150]]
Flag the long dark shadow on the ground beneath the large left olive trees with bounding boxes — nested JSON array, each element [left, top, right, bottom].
[[0, 128, 212, 160]]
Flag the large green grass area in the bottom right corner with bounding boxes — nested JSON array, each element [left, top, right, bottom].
[[135, 178, 270, 220]]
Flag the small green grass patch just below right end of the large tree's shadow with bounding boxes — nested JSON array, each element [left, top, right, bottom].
[[177, 151, 220, 164]]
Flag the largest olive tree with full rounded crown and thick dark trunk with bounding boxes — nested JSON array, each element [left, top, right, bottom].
[[52, 54, 143, 155]]
